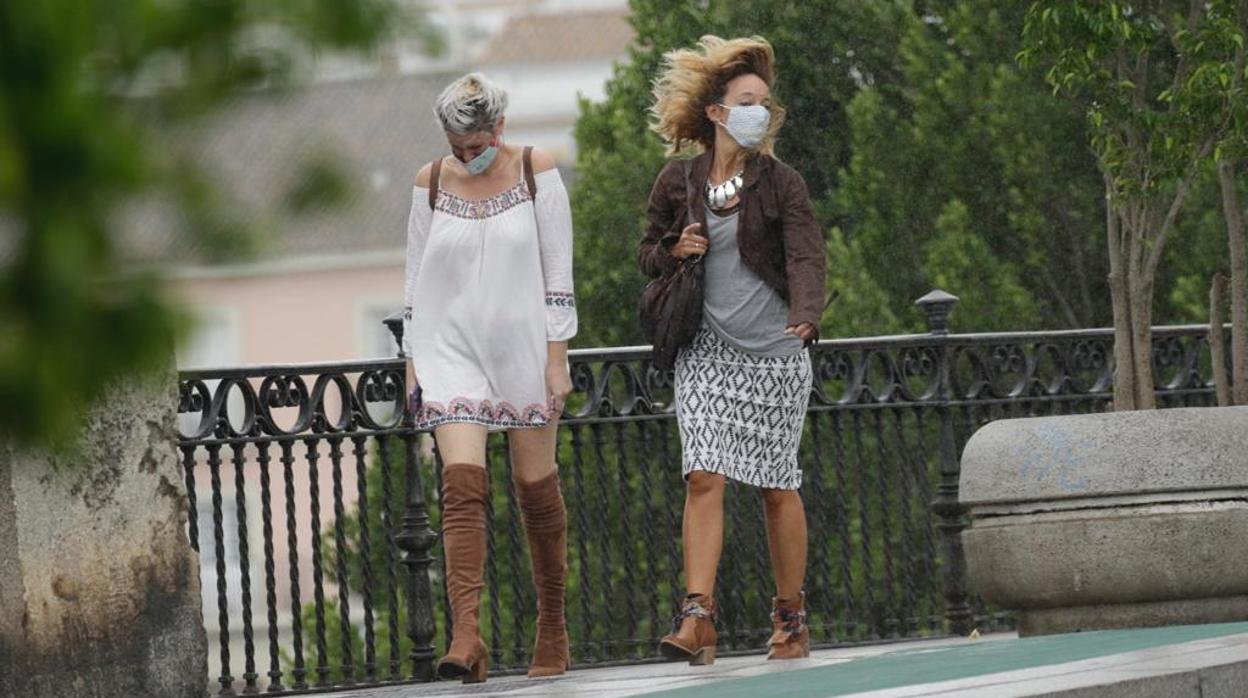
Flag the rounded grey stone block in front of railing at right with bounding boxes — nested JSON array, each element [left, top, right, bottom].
[[960, 407, 1248, 636]]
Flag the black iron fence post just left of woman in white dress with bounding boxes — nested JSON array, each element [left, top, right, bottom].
[[384, 313, 438, 681]]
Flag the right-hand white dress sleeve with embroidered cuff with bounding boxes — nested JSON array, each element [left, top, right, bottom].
[[534, 169, 577, 342]]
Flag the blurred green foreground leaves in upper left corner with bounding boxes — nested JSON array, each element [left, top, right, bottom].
[[0, 0, 409, 442]]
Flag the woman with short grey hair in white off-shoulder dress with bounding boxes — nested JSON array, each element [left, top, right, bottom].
[[403, 72, 577, 682]]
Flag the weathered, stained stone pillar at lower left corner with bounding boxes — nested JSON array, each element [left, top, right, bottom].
[[0, 371, 207, 698]]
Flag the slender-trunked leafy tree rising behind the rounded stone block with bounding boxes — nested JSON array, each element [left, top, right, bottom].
[[1020, 0, 1248, 410]]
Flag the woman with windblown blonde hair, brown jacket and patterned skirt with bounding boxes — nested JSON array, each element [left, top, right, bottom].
[[639, 36, 825, 664]]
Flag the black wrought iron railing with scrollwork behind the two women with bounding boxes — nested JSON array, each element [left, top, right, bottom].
[[180, 292, 1213, 694]]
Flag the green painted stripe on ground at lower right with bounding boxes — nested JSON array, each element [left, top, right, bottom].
[[646, 623, 1248, 698]]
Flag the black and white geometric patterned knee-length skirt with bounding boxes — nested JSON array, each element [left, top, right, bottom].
[[676, 327, 811, 489]]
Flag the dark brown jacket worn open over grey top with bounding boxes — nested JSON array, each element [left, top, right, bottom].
[[638, 151, 826, 332]]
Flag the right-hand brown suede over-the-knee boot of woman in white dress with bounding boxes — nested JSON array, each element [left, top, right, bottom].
[[515, 472, 572, 677]]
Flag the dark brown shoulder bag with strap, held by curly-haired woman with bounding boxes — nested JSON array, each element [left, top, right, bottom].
[[638, 160, 705, 371]]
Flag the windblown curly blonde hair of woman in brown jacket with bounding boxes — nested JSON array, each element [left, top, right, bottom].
[[650, 35, 785, 155]]
